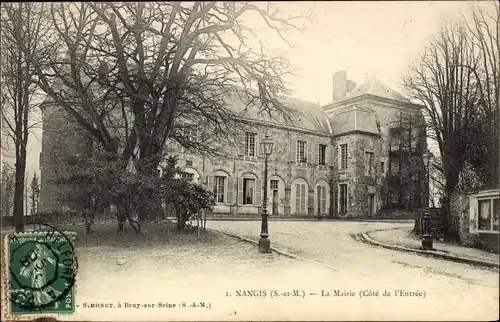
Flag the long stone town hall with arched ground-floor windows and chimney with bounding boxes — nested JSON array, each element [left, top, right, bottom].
[[40, 71, 427, 217]]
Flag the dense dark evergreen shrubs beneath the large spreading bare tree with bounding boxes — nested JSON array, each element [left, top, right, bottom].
[[58, 151, 215, 232]]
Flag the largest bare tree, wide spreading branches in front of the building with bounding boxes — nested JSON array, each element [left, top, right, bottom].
[[23, 2, 312, 221]]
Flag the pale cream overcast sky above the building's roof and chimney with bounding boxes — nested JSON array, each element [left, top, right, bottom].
[[2, 1, 471, 199]]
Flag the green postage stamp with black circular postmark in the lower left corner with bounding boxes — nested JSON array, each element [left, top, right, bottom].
[[8, 223, 77, 313]]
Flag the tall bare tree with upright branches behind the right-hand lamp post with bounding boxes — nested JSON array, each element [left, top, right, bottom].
[[403, 23, 481, 237]]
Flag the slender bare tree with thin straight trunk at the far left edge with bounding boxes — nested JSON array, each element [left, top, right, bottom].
[[1, 2, 51, 232]]
